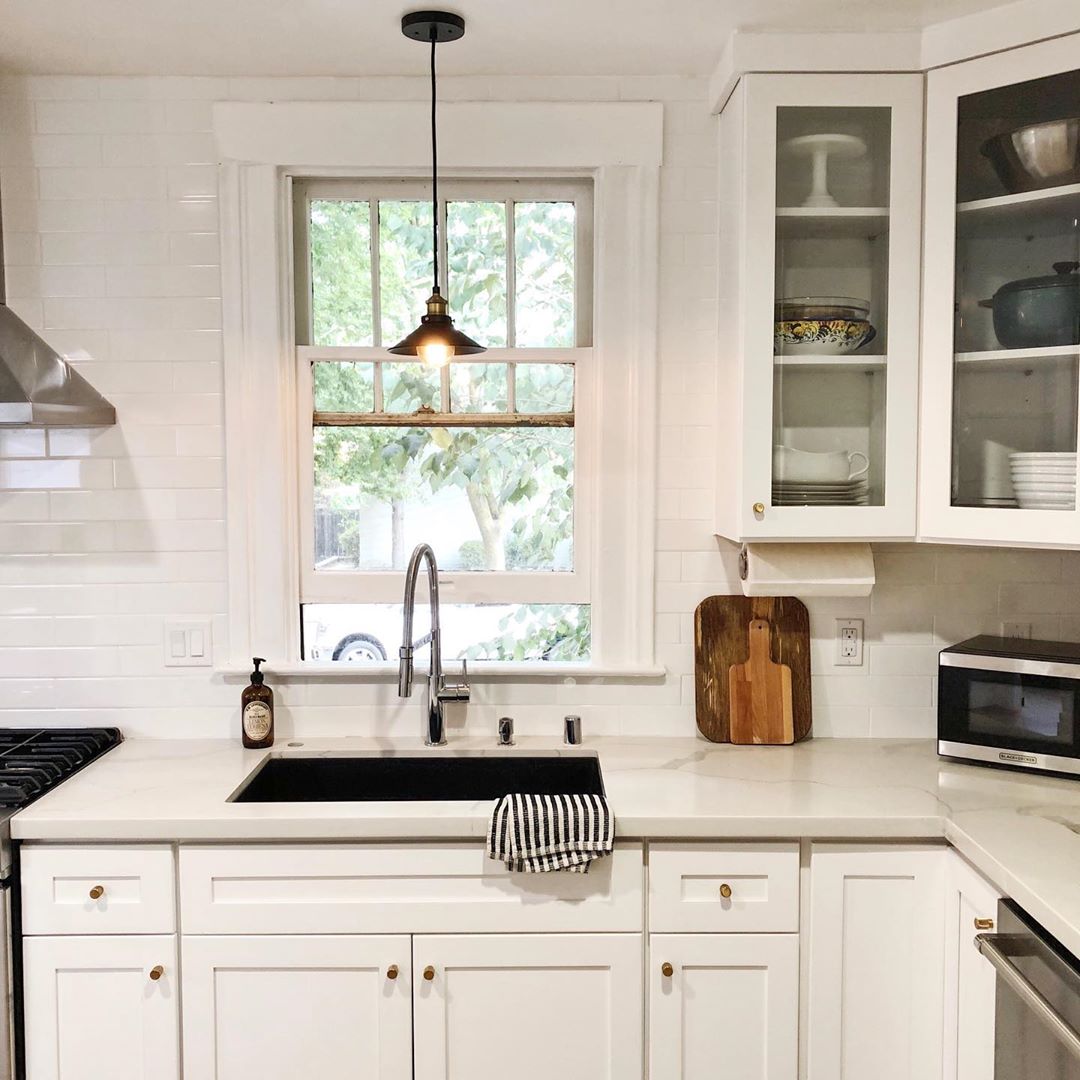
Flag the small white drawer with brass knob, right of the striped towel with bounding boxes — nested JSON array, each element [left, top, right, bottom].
[[649, 843, 799, 933]]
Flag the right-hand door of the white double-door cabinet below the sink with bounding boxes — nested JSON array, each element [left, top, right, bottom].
[[413, 934, 644, 1080]]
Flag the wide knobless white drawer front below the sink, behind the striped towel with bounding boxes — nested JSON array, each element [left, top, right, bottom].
[[180, 841, 643, 934]]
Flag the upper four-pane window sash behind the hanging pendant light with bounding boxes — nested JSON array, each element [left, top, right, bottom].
[[296, 180, 592, 349]]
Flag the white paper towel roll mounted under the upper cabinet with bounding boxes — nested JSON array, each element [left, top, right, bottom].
[[739, 543, 874, 596]]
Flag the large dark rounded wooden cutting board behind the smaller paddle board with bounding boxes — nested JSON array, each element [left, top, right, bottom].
[[693, 595, 811, 742]]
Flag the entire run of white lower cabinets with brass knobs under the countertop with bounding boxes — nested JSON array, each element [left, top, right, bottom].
[[23, 841, 997, 1080]]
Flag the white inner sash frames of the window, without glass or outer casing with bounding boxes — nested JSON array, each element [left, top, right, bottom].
[[293, 181, 596, 604]]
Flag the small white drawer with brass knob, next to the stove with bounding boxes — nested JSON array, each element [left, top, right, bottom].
[[22, 845, 176, 934]]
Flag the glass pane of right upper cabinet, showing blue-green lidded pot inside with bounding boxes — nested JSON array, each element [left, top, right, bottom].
[[950, 71, 1080, 513]]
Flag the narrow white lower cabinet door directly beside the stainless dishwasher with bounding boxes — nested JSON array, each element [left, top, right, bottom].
[[945, 851, 1001, 1080]]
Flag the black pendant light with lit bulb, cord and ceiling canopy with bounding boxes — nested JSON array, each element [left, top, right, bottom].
[[390, 11, 484, 367]]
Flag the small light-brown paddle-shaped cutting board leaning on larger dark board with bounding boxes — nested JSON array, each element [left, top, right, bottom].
[[728, 619, 795, 745]]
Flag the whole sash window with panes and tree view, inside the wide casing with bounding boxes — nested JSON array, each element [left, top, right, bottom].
[[293, 178, 595, 662]]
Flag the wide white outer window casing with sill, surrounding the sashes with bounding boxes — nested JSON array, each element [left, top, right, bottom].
[[214, 102, 663, 680]]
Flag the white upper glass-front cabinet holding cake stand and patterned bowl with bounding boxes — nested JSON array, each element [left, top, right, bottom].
[[716, 75, 922, 540]]
